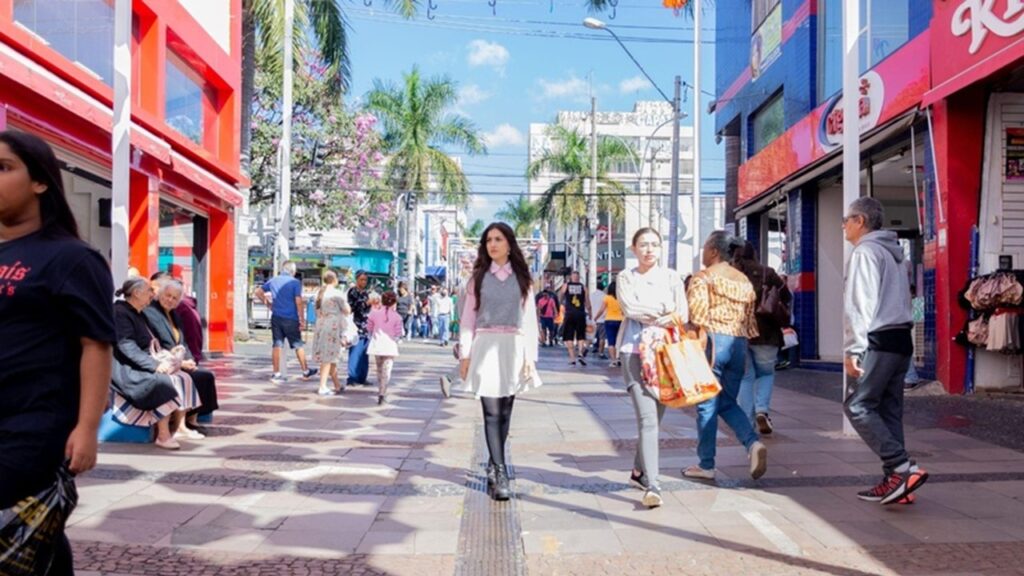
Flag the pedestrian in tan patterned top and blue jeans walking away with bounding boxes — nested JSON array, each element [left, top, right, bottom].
[[683, 231, 768, 480]]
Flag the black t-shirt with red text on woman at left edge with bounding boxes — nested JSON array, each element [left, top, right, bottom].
[[0, 232, 116, 508]]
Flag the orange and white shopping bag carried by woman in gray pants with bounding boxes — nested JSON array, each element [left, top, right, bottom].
[[640, 317, 722, 408]]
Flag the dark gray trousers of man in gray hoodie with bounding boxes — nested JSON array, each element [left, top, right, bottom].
[[843, 351, 910, 476]]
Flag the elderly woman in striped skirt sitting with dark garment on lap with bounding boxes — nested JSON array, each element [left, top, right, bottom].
[[112, 278, 201, 450]]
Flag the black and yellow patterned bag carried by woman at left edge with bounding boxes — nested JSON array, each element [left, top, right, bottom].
[[0, 465, 78, 576]]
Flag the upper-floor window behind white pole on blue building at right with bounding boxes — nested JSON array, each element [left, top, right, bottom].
[[818, 0, 910, 102]]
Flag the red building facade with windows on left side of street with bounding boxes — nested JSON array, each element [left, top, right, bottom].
[[0, 0, 243, 352]]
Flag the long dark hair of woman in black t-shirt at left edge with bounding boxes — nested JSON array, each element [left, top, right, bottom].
[[0, 130, 79, 239]]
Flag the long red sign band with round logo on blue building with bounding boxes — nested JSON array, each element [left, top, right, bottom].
[[738, 32, 930, 205]]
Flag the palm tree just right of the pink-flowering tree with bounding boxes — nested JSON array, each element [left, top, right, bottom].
[[367, 67, 486, 281]]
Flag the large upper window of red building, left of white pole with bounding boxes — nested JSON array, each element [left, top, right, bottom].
[[14, 0, 114, 85]]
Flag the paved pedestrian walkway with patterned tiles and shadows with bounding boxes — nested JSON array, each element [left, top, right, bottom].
[[69, 343, 1024, 576]]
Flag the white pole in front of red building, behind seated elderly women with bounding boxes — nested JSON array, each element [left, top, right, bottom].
[[111, 0, 132, 285]]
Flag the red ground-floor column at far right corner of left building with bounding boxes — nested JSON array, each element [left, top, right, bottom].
[[207, 204, 234, 353]]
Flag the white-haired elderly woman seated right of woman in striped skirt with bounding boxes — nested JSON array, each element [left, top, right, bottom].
[[142, 275, 218, 432]]
